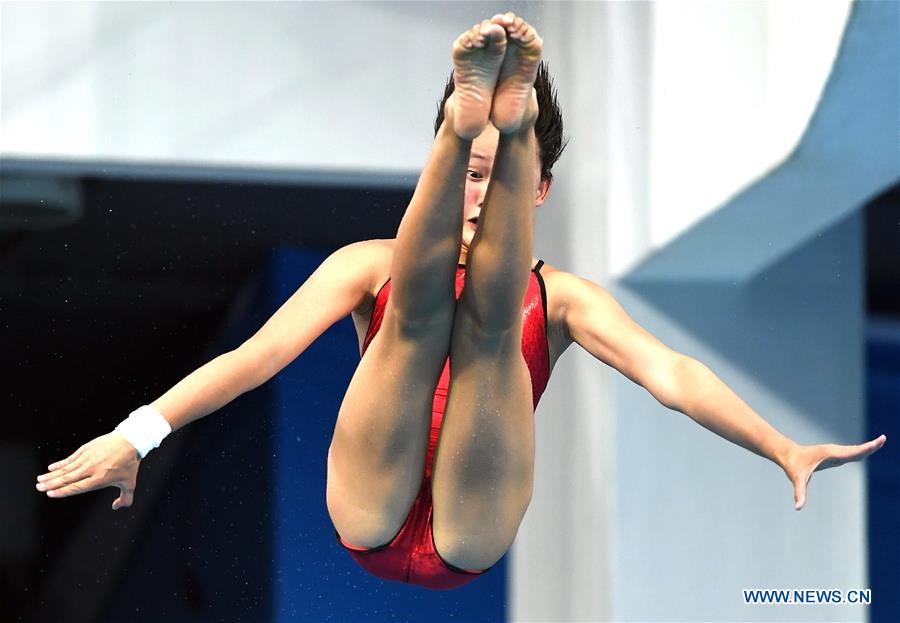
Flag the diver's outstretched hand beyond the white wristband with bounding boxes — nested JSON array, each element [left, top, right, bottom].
[[37, 431, 141, 510]]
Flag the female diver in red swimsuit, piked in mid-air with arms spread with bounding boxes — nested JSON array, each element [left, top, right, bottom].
[[37, 13, 885, 588]]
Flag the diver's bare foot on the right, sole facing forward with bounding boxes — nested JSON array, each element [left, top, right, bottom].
[[491, 13, 544, 134]]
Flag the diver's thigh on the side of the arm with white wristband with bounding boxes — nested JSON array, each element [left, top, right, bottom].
[[326, 301, 452, 547]]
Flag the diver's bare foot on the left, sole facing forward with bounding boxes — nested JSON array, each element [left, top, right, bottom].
[[447, 19, 506, 140]]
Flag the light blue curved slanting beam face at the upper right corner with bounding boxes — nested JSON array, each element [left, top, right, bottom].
[[623, 1, 900, 285]]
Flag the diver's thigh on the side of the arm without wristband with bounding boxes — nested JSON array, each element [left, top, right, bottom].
[[432, 308, 534, 569]]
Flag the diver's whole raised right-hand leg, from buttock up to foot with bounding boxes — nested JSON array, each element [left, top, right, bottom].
[[432, 14, 541, 569]]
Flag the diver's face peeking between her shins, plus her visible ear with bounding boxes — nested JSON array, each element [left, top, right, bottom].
[[462, 123, 550, 251]]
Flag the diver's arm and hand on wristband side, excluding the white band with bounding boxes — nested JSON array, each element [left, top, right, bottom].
[[36, 240, 384, 510]]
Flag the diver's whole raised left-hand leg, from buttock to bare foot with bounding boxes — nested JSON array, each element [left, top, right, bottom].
[[326, 21, 506, 547]]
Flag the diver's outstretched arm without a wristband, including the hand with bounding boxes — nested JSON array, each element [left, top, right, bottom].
[[554, 273, 885, 510]]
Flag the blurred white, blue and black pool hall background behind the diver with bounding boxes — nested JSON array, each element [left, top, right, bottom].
[[0, 0, 900, 622]]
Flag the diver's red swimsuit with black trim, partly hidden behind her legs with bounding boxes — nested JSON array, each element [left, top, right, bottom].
[[335, 260, 550, 589]]
